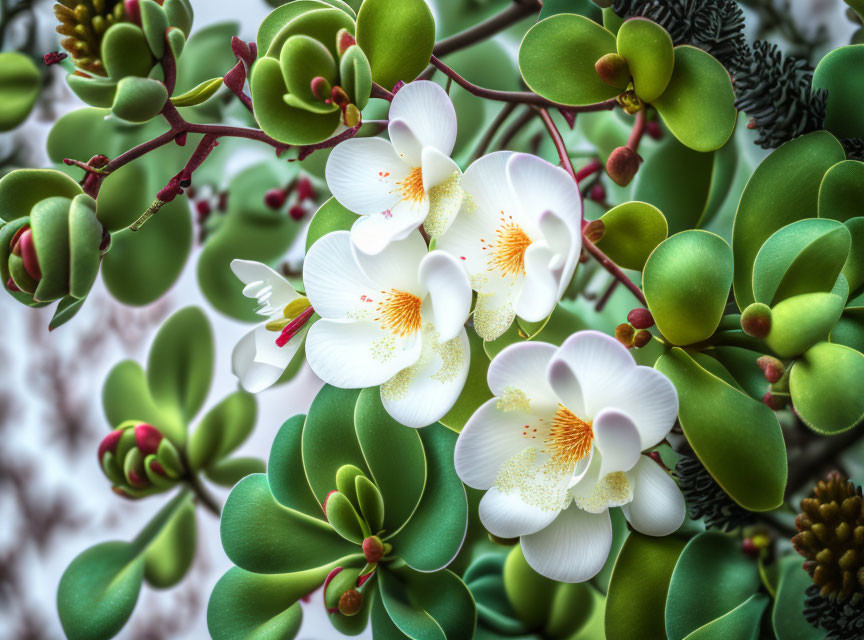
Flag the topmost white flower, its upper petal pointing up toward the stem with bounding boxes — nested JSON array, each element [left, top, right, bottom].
[[326, 80, 462, 254]]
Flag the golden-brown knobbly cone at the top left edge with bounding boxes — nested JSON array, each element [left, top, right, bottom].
[[54, 0, 126, 76]]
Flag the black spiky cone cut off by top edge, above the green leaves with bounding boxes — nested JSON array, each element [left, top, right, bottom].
[[612, 0, 747, 69]]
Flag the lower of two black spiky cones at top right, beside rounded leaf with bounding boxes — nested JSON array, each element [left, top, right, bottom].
[[733, 42, 828, 149]]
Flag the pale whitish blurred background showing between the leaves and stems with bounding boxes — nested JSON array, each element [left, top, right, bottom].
[[0, 0, 855, 640]]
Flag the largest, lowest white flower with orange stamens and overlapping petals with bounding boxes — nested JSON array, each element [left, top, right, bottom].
[[454, 331, 684, 582]]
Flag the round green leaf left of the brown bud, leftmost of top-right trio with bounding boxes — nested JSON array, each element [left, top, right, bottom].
[[519, 13, 619, 105]]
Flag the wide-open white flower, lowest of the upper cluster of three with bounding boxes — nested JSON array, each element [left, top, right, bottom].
[[303, 230, 471, 427]]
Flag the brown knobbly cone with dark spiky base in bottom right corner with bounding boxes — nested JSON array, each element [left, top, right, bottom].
[[792, 471, 864, 640]]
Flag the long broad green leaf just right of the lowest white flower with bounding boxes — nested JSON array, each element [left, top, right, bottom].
[[655, 348, 787, 511]]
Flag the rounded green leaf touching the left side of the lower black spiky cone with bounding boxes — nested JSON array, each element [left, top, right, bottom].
[[656, 45, 738, 151]]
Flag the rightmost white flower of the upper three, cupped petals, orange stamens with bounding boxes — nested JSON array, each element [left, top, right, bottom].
[[436, 151, 582, 340]]
